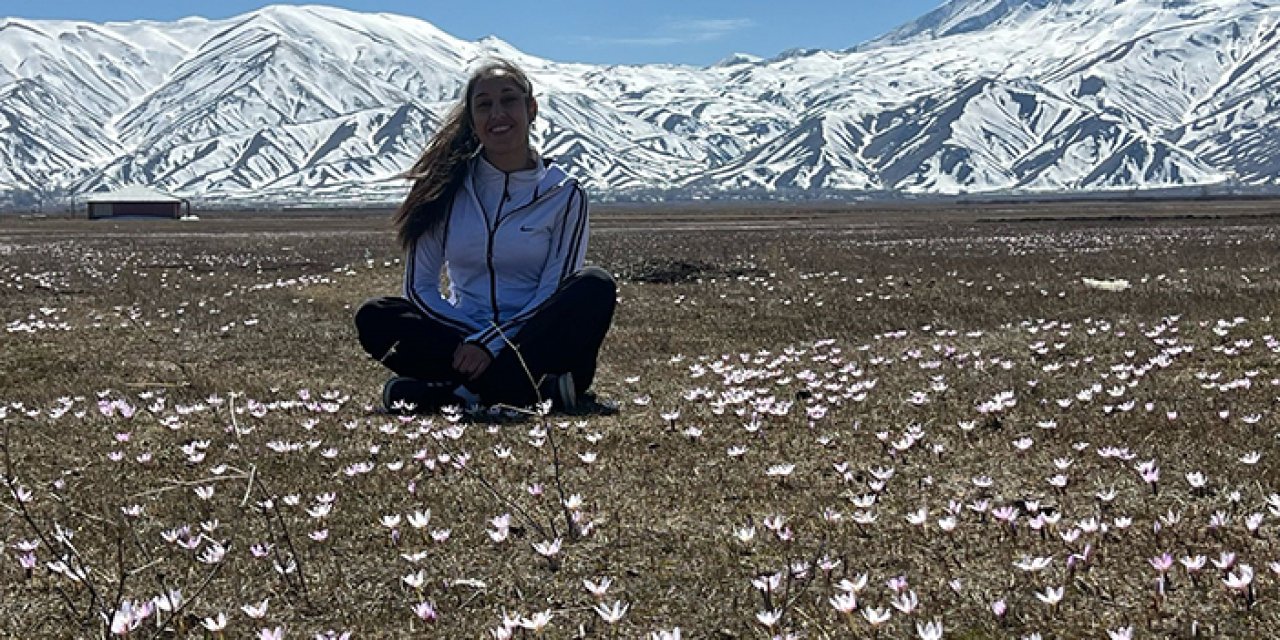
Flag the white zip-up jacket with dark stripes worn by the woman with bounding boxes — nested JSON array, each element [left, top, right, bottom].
[[404, 155, 589, 356]]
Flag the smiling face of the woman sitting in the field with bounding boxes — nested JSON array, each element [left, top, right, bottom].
[[471, 76, 538, 157]]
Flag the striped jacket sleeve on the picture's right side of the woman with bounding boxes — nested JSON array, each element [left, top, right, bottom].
[[467, 186, 590, 356]]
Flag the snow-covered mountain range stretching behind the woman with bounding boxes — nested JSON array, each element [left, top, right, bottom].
[[0, 0, 1280, 205]]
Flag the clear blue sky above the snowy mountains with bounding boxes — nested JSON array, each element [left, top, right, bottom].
[[0, 0, 943, 65]]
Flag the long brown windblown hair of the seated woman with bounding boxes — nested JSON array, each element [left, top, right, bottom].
[[392, 59, 534, 250]]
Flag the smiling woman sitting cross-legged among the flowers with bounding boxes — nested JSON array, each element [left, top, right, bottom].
[[356, 60, 617, 411]]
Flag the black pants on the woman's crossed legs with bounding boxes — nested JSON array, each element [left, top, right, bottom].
[[356, 266, 617, 406]]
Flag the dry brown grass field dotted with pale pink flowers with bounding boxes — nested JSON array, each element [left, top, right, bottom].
[[0, 201, 1280, 639]]
